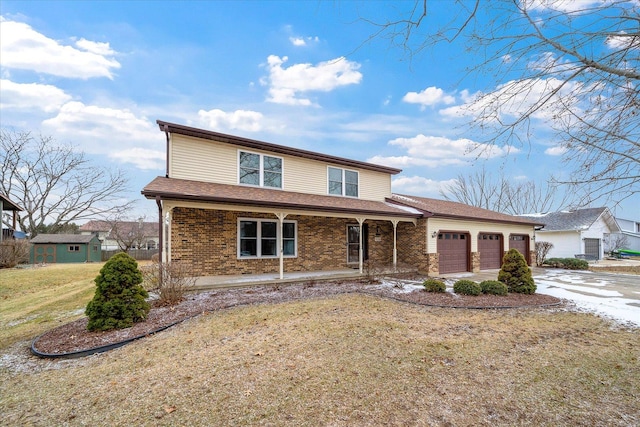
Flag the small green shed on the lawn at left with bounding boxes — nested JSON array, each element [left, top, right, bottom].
[[29, 234, 102, 264]]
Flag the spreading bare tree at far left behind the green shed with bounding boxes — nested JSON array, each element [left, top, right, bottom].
[[0, 129, 131, 236]]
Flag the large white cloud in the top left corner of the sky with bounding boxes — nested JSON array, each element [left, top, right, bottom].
[[0, 18, 120, 79]]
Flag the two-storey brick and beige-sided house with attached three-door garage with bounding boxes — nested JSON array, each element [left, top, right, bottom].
[[142, 121, 541, 278]]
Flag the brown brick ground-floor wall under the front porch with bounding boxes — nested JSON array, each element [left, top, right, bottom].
[[171, 208, 400, 276]]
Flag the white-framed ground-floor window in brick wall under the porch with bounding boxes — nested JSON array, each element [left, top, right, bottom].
[[238, 218, 298, 258]]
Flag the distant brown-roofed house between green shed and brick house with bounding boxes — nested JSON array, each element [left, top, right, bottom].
[[79, 220, 160, 251]]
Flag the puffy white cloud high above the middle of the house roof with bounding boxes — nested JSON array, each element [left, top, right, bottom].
[[262, 55, 362, 106]]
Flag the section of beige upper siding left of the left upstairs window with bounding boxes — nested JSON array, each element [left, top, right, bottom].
[[169, 134, 238, 184]]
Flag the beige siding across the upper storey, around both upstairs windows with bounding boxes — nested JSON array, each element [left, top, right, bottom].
[[169, 134, 391, 201]]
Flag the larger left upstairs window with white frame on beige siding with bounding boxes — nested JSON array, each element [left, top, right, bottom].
[[238, 151, 282, 188]]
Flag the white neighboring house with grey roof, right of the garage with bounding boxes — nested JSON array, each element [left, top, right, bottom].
[[523, 208, 620, 260]]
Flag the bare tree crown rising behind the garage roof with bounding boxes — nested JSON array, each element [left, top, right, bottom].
[[440, 167, 577, 215]]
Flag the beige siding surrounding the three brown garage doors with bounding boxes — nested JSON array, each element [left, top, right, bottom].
[[427, 218, 533, 253]]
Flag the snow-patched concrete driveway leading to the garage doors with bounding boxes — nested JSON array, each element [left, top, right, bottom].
[[445, 267, 640, 327]]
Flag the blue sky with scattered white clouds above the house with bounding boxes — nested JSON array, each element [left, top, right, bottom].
[[0, 0, 640, 220]]
